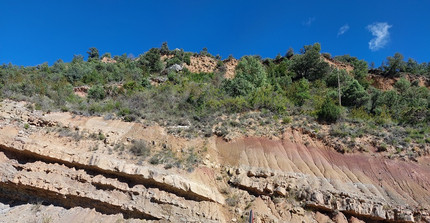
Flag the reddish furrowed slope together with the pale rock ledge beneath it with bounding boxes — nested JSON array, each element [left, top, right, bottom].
[[217, 131, 430, 221]]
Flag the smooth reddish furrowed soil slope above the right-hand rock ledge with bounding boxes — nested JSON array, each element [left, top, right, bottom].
[[217, 132, 430, 207]]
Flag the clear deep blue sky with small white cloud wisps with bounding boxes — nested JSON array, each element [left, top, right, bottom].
[[0, 0, 430, 66]]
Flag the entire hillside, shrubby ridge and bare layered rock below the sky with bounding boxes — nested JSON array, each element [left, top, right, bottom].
[[0, 44, 430, 223]]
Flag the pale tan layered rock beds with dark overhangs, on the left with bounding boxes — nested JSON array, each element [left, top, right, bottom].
[[0, 101, 224, 222]]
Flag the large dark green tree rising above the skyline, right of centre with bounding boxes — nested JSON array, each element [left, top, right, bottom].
[[291, 43, 330, 81]]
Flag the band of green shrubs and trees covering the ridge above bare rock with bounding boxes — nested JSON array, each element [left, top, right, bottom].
[[0, 43, 430, 159]]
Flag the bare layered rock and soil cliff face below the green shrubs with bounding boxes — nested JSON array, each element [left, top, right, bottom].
[[0, 101, 430, 222]]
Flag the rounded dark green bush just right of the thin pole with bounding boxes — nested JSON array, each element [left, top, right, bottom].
[[342, 80, 369, 107]]
